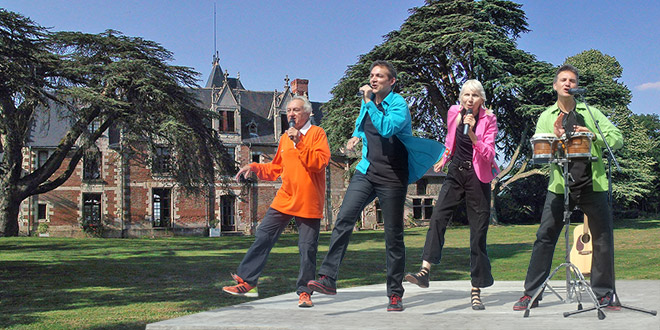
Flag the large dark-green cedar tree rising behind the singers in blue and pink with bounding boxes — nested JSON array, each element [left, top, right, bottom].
[[323, 0, 553, 221]]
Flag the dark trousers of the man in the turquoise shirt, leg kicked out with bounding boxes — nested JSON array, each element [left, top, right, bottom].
[[319, 171, 407, 296]]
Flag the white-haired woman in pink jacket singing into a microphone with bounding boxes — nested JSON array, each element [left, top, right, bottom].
[[406, 80, 499, 310]]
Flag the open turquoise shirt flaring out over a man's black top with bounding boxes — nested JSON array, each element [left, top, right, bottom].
[[353, 92, 445, 183]]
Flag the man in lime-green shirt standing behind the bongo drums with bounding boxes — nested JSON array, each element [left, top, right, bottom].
[[513, 65, 623, 311]]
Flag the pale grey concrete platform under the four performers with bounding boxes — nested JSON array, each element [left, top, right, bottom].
[[146, 280, 660, 330]]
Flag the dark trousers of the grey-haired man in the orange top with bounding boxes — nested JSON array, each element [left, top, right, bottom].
[[236, 208, 321, 294]]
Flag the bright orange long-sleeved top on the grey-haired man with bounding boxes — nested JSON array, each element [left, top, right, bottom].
[[250, 122, 330, 219]]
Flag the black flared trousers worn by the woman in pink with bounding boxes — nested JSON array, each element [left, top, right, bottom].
[[422, 162, 493, 288]]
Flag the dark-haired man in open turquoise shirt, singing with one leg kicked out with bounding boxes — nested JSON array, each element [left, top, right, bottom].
[[307, 61, 444, 311]]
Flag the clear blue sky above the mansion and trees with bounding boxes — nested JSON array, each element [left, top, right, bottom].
[[0, 0, 660, 113]]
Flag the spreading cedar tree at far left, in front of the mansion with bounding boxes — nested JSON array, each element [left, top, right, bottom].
[[0, 9, 233, 236]]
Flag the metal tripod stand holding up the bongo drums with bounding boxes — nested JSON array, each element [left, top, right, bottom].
[[523, 152, 605, 320]]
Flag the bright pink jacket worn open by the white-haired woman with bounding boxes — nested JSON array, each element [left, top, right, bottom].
[[443, 105, 500, 183]]
